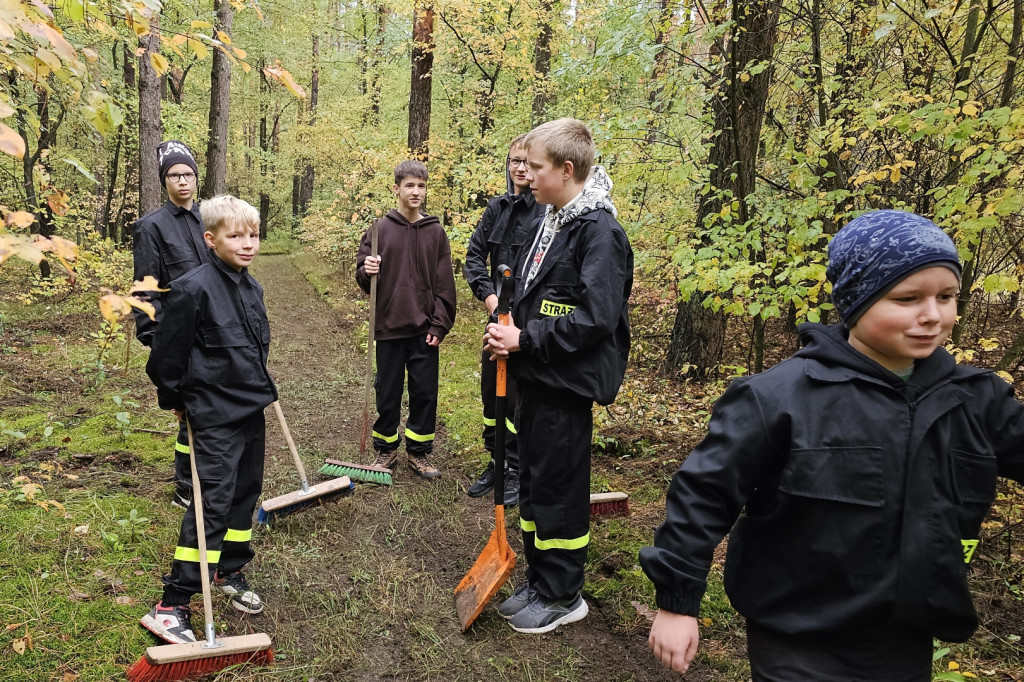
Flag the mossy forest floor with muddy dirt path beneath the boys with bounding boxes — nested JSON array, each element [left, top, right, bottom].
[[0, 246, 1024, 682]]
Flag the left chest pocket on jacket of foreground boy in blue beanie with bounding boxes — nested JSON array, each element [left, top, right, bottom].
[[778, 446, 886, 507]]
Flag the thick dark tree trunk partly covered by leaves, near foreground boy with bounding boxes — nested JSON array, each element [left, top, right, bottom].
[[665, 0, 780, 376]]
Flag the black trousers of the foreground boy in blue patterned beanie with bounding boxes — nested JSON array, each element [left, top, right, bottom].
[[746, 622, 932, 682]]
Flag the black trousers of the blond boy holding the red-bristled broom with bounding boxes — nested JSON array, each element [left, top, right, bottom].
[[164, 410, 266, 605]]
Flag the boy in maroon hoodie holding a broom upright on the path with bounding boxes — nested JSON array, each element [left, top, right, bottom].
[[355, 161, 455, 480]]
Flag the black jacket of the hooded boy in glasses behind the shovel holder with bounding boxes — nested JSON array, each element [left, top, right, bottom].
[[464, 187, 545, 301]]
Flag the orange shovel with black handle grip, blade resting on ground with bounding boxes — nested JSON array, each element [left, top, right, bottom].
[[455, 265, 515, 632]]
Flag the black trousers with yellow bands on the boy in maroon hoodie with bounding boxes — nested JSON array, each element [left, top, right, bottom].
[[374, 333, 439, 457]]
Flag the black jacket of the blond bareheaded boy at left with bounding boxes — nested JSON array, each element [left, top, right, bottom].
[[145, 256, 278, 428]]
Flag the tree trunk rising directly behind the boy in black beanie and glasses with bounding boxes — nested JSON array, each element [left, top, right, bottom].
[[138, 14, 164, 215]]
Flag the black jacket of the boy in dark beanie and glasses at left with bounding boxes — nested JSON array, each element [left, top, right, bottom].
[[132, 202, 213, 346]]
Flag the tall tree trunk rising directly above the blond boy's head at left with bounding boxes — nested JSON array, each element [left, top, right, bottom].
[[200, 0, 234, 199]]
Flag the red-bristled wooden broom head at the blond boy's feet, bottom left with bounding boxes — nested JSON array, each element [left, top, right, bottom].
[[126, 633, 273, 682]]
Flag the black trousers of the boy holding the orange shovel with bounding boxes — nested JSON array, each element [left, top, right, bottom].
[[519, 384, 594, 600]]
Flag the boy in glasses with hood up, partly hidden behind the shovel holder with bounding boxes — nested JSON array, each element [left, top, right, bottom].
[[465, 135, 544, 505]]
